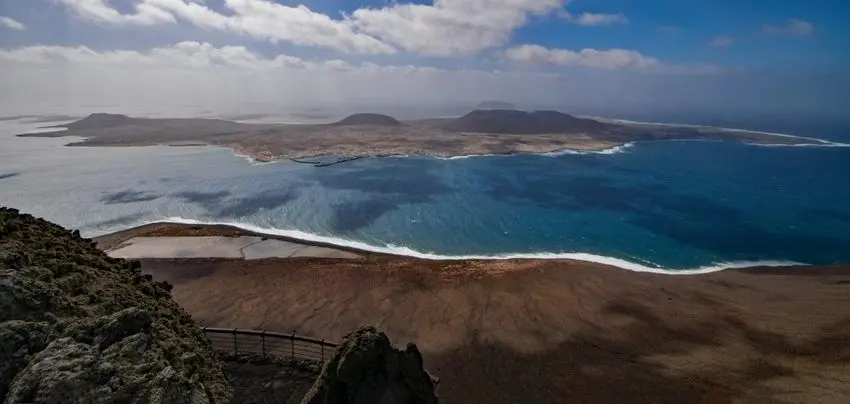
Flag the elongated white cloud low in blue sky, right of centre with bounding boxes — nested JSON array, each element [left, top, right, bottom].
[[505, 45, 660, 70]]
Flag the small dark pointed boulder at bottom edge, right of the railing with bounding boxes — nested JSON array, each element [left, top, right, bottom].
[[301, 327, 437, 404]]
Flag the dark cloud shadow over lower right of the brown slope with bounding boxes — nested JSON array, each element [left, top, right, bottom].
[[425, 300, 850, 404]]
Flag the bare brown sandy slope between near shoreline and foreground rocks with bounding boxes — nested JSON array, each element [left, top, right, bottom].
[[143, 256, 850, 403]]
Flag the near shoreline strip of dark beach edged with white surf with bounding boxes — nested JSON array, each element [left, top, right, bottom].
[[92, 218, 828, 276]]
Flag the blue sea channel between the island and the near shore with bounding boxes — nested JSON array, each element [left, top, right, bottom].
[[0, 113, 850, 273]]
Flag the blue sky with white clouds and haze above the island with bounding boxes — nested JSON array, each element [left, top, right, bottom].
[[0, 0, 850, 115]]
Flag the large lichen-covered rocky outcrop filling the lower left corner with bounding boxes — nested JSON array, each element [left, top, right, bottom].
[[0, 208, 231, 404]]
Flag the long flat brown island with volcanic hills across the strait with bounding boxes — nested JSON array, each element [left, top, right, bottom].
[[18, 109, 826, 162]]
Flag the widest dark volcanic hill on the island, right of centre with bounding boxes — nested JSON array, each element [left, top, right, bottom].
[[446, 110, 617, 134]]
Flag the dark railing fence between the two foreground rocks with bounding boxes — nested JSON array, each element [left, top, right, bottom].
[[201, 327, 337, 363]]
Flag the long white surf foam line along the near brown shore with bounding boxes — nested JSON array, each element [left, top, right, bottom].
[[143, 217, 807, 275]]
